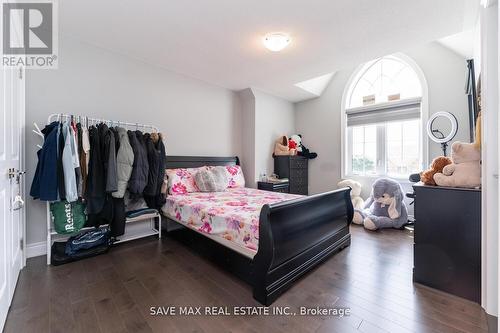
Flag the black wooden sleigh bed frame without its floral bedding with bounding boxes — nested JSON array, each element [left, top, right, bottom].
[[165, 156, 354, 306]]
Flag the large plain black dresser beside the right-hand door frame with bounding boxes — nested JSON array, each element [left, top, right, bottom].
[[413, 183, 481, 303]]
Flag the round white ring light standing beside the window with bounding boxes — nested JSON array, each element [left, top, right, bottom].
[[427, 111, 458, 156]]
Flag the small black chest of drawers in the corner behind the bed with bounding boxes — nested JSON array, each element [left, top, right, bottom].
[[274, 156, 309, 195]]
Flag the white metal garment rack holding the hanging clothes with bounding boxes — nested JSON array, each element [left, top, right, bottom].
[[47, 113, 161, 265]]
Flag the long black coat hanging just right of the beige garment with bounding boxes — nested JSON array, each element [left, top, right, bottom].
[[85, 126, 106, 214]]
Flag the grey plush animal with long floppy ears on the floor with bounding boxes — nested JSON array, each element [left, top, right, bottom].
[[353, 178, 408, 230]]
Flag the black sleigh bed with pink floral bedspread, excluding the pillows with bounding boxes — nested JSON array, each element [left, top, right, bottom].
[[162, 156, 354, 306]]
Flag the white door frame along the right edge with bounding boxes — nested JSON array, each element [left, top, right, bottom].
[[480, 0, 500, 316]]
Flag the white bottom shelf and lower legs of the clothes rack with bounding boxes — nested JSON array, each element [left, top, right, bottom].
[[47, 203, 161, 265]]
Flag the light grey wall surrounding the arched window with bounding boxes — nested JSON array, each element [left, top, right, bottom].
[[295, 43, 469, 198]]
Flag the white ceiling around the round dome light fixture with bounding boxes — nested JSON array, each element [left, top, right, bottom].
[[59, 0, 479, 102]]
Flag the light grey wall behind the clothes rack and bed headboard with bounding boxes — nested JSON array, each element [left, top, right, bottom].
[[26, 38, 241, 246]]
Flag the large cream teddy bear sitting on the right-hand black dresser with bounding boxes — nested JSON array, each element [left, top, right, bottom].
[[434, 141, 481, 188]]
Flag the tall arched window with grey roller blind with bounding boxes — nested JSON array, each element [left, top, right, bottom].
[[344, 55, 423, 178]]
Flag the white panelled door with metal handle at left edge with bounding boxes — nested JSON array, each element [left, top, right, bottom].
[[0, 63, 25, 329]]
